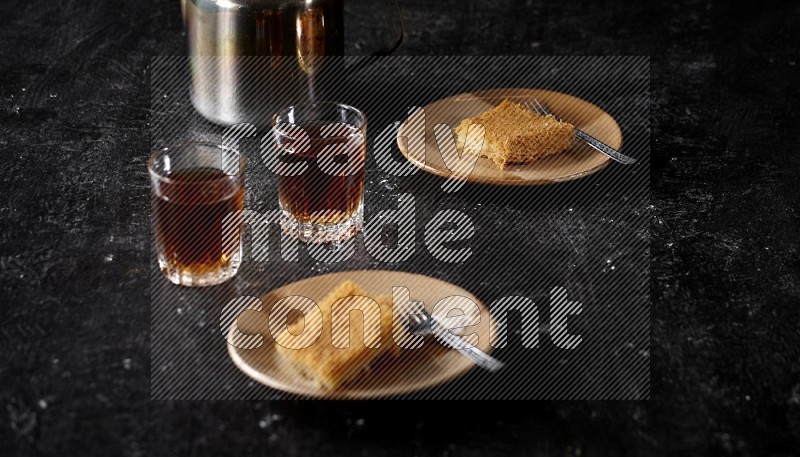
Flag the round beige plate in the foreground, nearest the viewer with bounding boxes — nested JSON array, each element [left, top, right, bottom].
[[228, 270, 491, 399]]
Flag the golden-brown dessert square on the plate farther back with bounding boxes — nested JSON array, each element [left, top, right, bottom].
[[455, 99, 575, 169]]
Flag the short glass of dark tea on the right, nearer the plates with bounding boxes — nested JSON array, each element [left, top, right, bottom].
[[272, 102, 367, 243]]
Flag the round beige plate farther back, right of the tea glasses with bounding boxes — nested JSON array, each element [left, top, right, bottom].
[[397, 89, 622, 186]]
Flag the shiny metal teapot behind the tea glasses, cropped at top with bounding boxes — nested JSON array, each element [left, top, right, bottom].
[[181, 0, 403, 126]]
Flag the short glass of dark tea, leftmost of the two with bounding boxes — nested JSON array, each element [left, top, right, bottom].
[[147, 142, 245, 286]]
